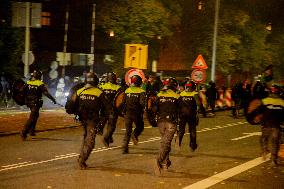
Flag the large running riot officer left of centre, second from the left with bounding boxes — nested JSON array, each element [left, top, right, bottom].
[[75, 72, 111, 169]]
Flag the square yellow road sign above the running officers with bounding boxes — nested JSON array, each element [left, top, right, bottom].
[[124, 44, 148, 69]]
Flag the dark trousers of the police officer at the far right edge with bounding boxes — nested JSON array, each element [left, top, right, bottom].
[[260, 127, 281, 160]]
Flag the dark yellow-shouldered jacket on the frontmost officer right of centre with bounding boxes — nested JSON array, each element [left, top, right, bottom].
[[156, 89, 180, 123]]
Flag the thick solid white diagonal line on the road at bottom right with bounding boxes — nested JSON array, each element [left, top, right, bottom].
[[183, 157, 268, 189]]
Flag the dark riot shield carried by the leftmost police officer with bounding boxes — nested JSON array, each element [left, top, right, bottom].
[[12, 79, 25, 106]]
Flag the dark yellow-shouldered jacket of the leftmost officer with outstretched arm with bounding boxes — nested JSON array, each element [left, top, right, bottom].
[[24, 79, 56, 107]]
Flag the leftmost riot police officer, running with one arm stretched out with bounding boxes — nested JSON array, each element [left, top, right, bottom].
[[20, 70, 56, 140]]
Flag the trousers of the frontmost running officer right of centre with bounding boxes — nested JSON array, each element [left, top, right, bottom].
[[157, 120, 177, 164]]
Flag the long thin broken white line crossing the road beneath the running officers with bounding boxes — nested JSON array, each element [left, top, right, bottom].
[[0, 122, 246, 172]]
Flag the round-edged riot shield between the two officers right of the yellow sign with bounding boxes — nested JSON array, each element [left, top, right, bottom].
[[146, 92, 158, 127]]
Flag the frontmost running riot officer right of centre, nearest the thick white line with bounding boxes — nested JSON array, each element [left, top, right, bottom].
[[154, 78, 180, 175]]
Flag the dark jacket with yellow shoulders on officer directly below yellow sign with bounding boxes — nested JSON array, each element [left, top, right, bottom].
[[125, 86, 146, 115]]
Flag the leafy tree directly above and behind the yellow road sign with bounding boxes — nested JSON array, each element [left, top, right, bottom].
[[97, 0, 180, 74]]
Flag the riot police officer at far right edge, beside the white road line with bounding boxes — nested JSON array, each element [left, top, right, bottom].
[[260, 85, 284, 166]]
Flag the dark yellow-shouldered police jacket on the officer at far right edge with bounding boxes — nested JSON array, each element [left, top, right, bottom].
[[262, 95, 284, 128]]
